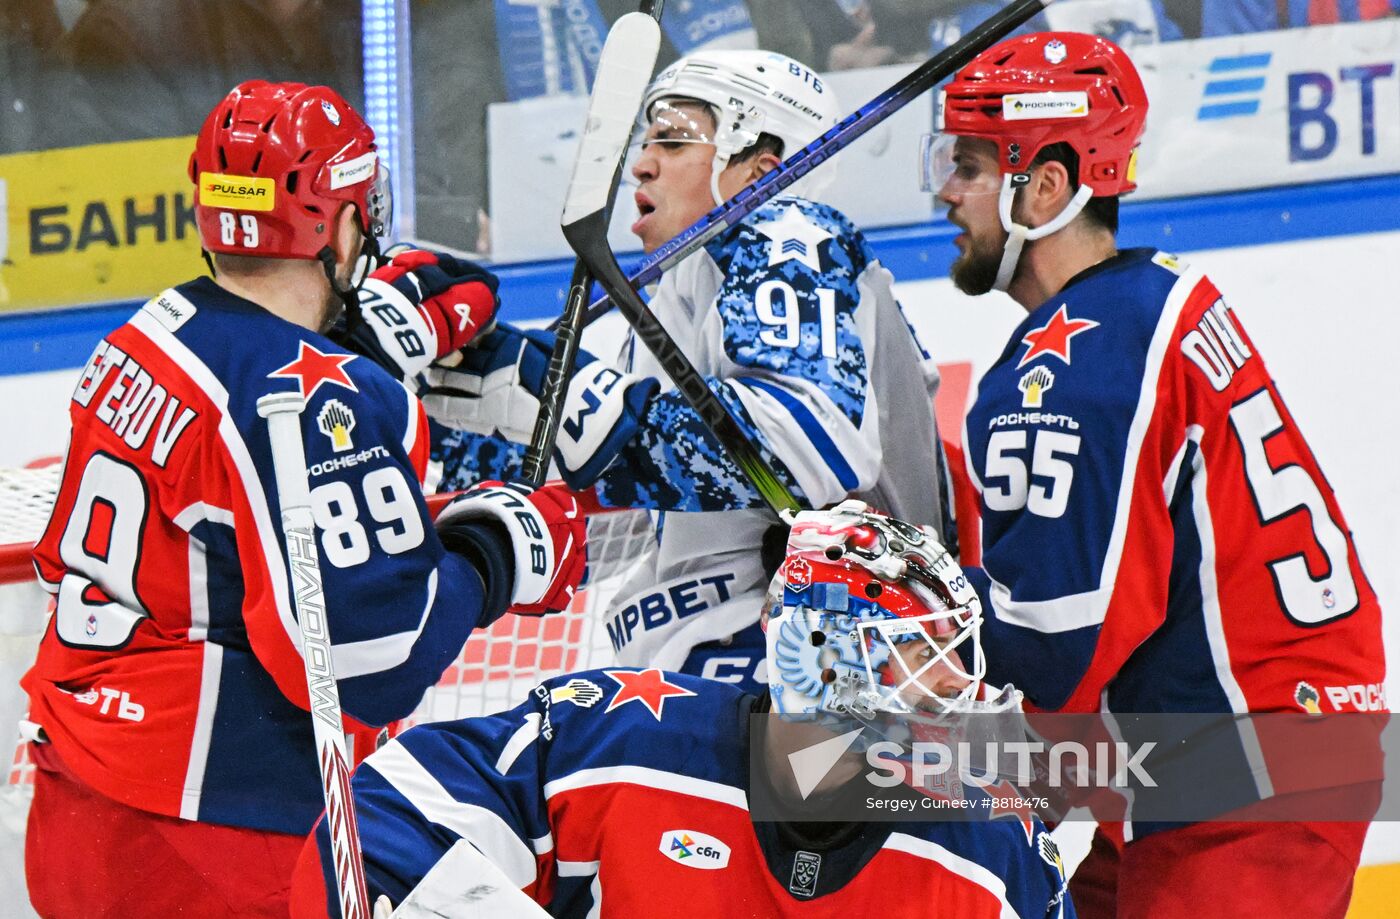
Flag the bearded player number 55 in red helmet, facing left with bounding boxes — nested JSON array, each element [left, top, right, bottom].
[[932, 34, 1385, 919]]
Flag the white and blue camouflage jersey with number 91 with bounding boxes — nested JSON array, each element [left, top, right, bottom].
[[434, 198, 944, 685]]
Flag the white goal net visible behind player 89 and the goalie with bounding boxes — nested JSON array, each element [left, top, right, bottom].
[[0, 464, 654, 790]]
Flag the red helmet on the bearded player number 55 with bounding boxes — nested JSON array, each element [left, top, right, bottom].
[[941, 32, 1147, 196]]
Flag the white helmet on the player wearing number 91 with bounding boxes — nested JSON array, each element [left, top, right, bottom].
[[641, 50, 840, 205]]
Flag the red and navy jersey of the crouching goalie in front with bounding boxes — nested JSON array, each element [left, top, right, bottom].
[[293, 670, 1074, 919]]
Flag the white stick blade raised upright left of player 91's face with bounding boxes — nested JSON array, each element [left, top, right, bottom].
[[560, 13, 661, 226]]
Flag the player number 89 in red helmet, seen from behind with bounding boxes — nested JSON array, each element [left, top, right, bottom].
[[24, 81, 584, 919]]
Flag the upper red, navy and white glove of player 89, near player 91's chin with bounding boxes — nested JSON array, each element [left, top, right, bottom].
[[350, 249, 501, 380]]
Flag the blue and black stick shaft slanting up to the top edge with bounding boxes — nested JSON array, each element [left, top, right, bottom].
[[562, 0, 1054, 333]]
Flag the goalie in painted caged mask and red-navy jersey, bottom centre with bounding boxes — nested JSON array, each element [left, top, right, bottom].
[[293, 500, 1074, 919]]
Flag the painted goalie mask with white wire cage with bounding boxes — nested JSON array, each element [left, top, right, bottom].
[[764, 500, 1021, 720]]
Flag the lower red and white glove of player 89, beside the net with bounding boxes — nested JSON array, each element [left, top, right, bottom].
[[437, 482, 588, 615]]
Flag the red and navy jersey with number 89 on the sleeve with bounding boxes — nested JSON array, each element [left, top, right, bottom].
[[24, 279, 505, 834]]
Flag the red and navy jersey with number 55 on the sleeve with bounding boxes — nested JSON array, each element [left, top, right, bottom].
[[963, 249, 1385, 713]]
